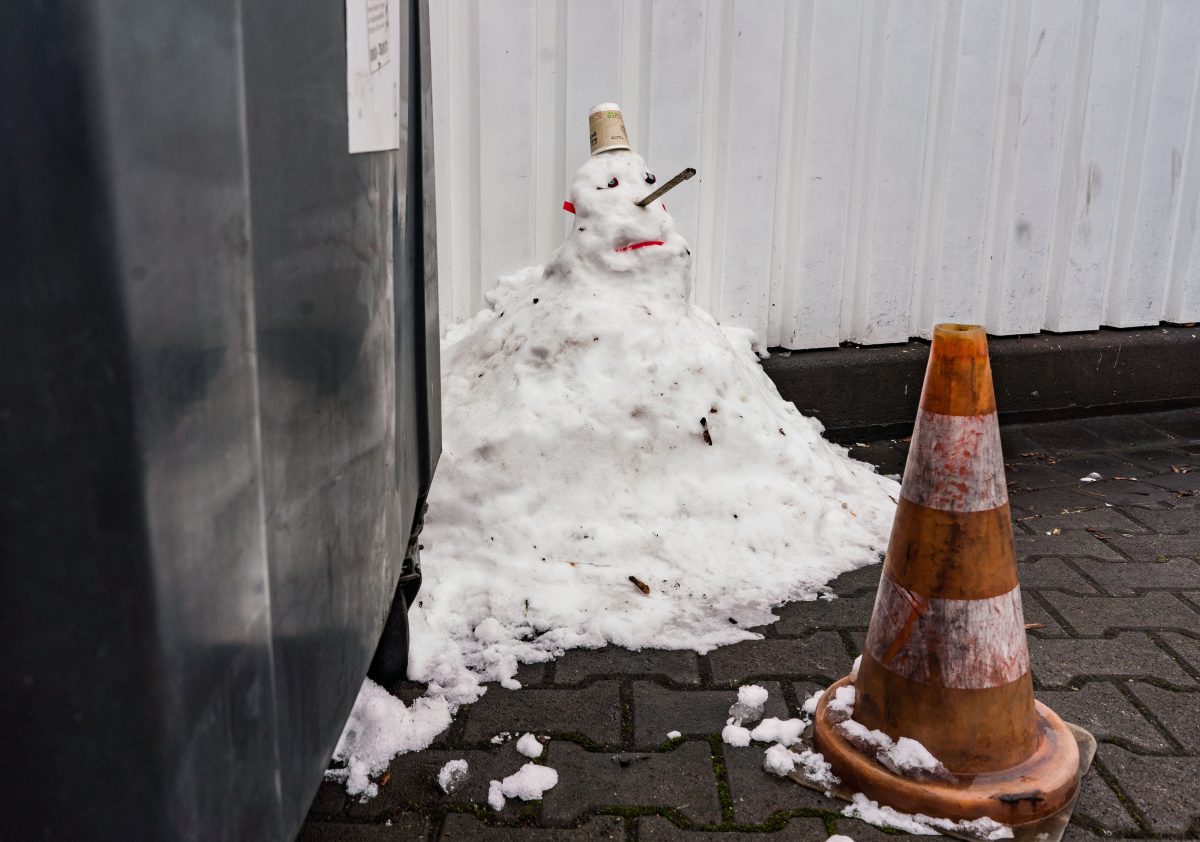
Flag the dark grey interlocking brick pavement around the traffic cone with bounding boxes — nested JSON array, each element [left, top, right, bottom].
[[300, 410, 1200, 842]]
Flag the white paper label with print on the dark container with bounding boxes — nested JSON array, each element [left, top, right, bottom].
[[346, 0, 406, 152]]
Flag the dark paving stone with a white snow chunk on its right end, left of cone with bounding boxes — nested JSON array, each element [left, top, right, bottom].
[[634, 681, 788, 748]]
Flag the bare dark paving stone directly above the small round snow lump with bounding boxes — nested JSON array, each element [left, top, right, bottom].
[[458, 681, 620, 745]]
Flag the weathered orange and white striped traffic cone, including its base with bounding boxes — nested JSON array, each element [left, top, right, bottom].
[[814, 324, 1080, 825]]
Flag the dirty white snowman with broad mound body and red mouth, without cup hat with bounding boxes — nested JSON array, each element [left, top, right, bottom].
[[410, 106, 899, 708]]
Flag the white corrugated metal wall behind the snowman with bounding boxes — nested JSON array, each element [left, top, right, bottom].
[[430, 0, 1200, 348]]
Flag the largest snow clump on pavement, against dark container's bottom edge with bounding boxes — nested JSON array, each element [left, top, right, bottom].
[[334, 679, 450, 799]]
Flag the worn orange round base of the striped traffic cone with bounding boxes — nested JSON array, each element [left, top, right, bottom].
[[812, 675, 1080, 826]]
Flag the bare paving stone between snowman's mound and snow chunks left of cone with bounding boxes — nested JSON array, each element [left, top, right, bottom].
[[708, 631, 852, 682]]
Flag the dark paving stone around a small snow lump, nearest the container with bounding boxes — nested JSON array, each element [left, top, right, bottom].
[[347, 740, 529, 820]]
